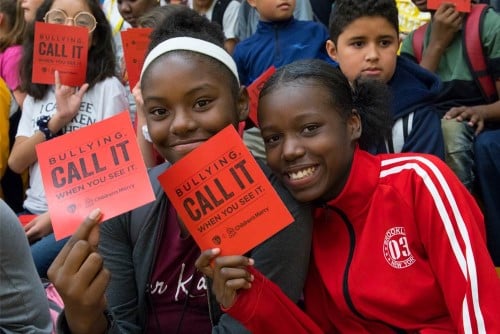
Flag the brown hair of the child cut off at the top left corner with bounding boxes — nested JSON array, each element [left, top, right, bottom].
[[0, 0, 26, 52]]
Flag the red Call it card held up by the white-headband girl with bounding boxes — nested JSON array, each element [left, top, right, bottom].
[[36, 111, 155, 240]]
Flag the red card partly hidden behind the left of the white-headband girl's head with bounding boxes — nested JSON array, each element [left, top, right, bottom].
[[121, 28, 153, 90]]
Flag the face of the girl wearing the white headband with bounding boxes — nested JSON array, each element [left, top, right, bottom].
[[141, 52, 248, 163]]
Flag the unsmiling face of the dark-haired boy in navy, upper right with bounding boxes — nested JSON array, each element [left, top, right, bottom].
[[326, 16, 399, 83]]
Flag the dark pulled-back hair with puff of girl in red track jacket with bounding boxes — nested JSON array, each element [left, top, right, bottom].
[[259, 59, 392, 150]]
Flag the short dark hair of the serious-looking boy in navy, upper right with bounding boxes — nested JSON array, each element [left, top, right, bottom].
[[329, 0, 399, 44]]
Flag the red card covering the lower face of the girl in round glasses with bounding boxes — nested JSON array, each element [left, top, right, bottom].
[[31, 22, 89, 87]]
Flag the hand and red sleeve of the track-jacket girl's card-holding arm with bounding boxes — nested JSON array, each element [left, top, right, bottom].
[[196, 249, 322, 334]]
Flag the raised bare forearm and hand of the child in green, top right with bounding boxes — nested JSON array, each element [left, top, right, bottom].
[[420, 3, 463, 72]]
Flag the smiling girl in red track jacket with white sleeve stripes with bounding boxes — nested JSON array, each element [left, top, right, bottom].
[[198, 61, 500, 334]]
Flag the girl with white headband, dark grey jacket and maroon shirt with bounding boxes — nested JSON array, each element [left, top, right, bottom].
[[49, 9, 311, 333]]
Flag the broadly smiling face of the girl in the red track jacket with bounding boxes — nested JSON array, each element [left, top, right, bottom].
[[259, 80, 361, 202]]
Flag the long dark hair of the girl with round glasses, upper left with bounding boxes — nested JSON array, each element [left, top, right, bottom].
[[21, 0, 116, 99]]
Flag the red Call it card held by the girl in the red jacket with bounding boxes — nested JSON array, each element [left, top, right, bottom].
[[158, 126, 293, 255]]
